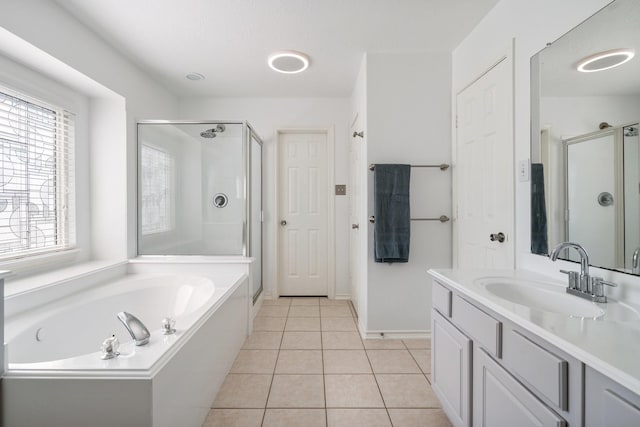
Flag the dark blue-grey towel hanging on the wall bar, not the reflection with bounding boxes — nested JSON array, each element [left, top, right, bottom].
[[373, 164, 411, 263]]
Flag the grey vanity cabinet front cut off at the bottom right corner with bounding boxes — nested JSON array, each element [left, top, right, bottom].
[[584, 366, 640, 427]]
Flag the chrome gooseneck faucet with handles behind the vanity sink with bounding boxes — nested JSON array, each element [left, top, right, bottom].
[[549, 242, 616, 303]]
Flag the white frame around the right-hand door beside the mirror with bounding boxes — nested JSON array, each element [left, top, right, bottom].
[[451, 43, 517, 268]]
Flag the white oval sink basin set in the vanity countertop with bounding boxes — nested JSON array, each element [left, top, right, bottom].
[[477, 277, 605, 318]]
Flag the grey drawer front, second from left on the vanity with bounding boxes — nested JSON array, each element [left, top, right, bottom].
[[452, 295, 502, 358]]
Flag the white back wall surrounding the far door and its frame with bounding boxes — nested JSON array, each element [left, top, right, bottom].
[[178, 98, 350, 296]]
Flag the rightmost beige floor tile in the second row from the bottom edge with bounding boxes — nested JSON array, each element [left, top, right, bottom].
[[376, 374, 440, 408]]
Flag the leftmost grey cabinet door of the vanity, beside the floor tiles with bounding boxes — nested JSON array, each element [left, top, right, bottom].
[[431, 310, 471, 427]]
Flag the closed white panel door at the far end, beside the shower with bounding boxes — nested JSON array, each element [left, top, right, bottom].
[[278, 133, 328, 295]]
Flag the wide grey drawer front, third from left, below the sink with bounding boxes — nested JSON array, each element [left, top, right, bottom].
[[504, 330, 569, 411]]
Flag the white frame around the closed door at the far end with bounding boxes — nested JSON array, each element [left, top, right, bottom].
[[272, 126, 336, 299]]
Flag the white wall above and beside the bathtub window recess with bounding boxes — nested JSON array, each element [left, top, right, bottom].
[[0, 0, 176, 259]]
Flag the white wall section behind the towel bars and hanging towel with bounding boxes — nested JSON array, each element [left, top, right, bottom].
[[362, 53, 451, 333]]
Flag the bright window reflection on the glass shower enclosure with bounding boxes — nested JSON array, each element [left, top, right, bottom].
[[140, 144, 175, 235]]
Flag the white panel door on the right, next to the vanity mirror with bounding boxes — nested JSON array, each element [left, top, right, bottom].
[[454, 57, 514, 268]]
